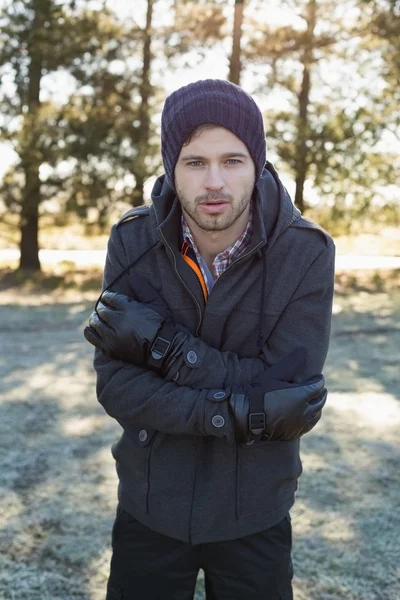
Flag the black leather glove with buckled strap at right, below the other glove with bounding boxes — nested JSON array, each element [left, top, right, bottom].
[[229, 348, 328, 442]]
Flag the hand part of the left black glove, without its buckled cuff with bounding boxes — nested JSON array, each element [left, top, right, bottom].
[[84, 290, 165, 365]]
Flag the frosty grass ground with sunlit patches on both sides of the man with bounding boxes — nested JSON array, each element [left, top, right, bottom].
[[0, 271, 400, 600]]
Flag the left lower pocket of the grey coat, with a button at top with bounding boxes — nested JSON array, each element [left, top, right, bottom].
[[111, 425, 158, 512]]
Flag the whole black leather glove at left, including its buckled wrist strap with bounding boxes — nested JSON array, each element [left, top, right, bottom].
[[84, 290, 187, 370]]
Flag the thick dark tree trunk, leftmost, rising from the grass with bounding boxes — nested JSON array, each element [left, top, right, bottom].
[[19, 0, 50, 272]]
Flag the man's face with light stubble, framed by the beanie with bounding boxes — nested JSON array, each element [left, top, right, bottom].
[[175, 127, 255, 231]]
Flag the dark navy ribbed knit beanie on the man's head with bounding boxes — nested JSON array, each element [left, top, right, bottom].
[[161, 79, 266, 188]]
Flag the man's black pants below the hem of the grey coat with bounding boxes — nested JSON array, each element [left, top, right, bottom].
[[106, 507, 293, 600]]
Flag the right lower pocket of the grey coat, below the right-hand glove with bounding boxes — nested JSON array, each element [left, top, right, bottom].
[[237, 440, 302, 517]]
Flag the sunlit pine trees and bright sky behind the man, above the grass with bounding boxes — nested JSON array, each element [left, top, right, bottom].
[[0, 0, 400, 271]]
